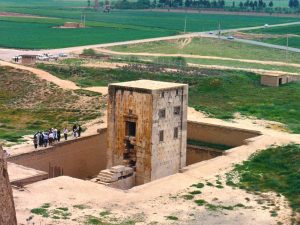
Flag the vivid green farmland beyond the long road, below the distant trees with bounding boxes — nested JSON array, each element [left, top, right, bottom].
[[0, 0, 299, 49]]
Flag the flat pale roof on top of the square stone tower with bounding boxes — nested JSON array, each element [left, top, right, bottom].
[[109, 80, 186, 90]]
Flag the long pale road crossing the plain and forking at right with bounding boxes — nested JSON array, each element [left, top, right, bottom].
[[0, 22, 300, 61]]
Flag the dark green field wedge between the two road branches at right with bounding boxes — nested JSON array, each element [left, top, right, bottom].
[[247, 25, 300, 48]]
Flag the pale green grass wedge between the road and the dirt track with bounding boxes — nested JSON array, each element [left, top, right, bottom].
[[111, 38, 300, 63]]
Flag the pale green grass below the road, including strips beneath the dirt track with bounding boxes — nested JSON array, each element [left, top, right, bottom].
[[110, 38, 300, 73]]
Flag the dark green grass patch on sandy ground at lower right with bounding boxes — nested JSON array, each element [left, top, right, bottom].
[[227, 144, 300, 216]]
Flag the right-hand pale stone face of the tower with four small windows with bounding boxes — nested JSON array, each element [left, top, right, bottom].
[[151, 86, 188, 180]]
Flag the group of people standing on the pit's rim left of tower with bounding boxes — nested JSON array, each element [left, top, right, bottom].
[[33, 124, 82, 149]]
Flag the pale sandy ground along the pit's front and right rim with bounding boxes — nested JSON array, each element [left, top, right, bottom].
[[14, 109, 300, 225]]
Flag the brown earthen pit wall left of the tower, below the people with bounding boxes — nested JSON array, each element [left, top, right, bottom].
[[8, 129, 107, 179]]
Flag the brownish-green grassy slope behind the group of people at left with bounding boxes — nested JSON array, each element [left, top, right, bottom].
[[0, 67, 101, 142]]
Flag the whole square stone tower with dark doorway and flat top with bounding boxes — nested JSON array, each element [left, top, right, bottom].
[[107, 80, 188, 185]]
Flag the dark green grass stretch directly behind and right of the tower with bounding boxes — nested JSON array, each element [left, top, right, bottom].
[[39, 62, 300, 133]]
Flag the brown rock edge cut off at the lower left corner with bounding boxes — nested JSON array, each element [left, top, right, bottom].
[[0, 146, 17, 225]]
